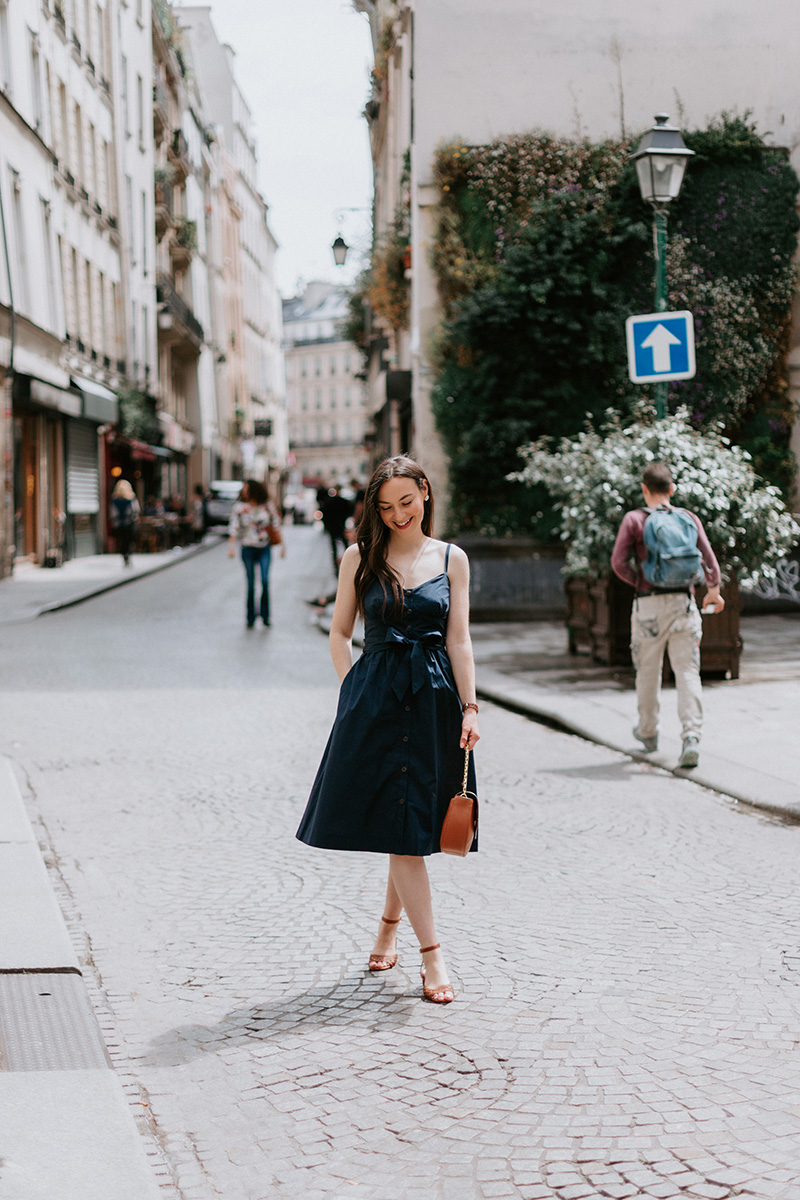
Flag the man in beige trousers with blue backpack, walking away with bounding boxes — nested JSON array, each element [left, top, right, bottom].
[[612, 462, 724, 767]]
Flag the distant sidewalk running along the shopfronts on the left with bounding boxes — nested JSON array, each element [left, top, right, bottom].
[[0, 534, 219, 625]]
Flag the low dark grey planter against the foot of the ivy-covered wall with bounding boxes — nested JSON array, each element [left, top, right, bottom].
[[456, 534, 565, 620]]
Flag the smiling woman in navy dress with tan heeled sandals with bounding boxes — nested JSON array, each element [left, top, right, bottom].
[[297, 455, 480, 1004]]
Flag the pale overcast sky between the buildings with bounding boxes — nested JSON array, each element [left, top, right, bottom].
[[175, 0, 372, 296]]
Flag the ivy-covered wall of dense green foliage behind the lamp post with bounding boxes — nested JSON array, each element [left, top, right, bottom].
[[432, 115, 800, 536]]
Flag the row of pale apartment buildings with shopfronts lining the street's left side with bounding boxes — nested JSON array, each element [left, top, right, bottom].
[[0, 0, 288, 576]]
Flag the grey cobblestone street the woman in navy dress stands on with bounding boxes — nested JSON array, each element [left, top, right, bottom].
[[0, 529, 800, 1200]]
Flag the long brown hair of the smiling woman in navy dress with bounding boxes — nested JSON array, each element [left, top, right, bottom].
[[355, 454, 433, 617]]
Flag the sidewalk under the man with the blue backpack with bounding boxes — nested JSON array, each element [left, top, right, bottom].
[[473, 613, 800, 818]]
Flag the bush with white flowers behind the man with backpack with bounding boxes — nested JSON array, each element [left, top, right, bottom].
[[510, 409, 800, 584]]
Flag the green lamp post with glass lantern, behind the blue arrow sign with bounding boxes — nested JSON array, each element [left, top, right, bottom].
[[633, 113, 694, 418]]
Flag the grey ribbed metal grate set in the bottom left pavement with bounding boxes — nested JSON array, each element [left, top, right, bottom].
[[0, 971, 110, 1070]]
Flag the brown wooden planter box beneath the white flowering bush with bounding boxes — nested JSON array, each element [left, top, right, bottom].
[[565, 575, 742, 680]]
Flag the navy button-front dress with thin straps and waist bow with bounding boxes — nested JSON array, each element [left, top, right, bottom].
[[297, 547, 477, 856]]
